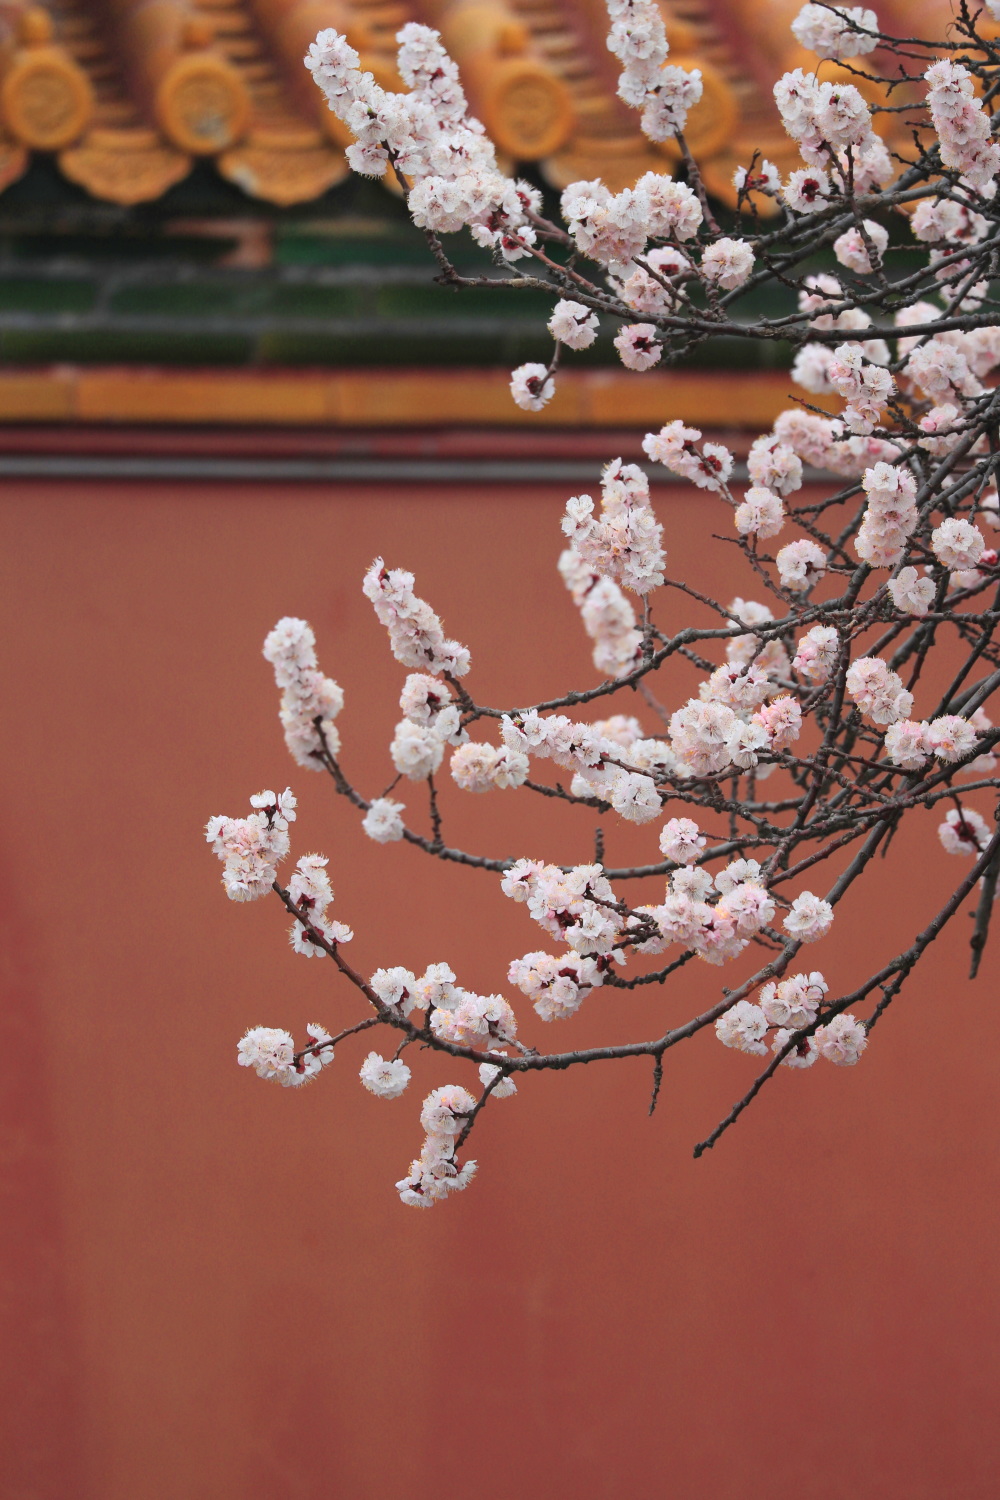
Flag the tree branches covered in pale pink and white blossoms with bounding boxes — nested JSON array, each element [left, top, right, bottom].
[[207, 0, 1000, 1206]]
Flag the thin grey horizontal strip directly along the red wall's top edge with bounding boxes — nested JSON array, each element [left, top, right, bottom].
[[0, 453, 758, 486]]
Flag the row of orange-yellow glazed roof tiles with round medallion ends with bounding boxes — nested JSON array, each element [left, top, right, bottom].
[[0, 0, 949, 206]]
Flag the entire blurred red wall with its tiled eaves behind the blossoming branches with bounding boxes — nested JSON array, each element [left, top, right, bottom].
[[0, 0, 1000, 1500]]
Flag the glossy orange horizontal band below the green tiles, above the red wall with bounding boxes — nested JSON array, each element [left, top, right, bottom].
[[0, 366, 821, 432]]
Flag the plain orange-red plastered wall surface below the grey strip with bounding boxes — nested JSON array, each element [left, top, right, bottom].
[[0, 483, 1000, 1500]]
